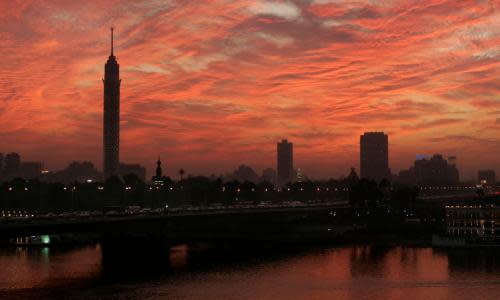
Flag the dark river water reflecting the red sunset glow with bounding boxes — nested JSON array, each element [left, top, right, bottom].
[[0, 246, 500, 300]]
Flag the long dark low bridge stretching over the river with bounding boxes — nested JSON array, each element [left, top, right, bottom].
[[0, 202, 348, 244]]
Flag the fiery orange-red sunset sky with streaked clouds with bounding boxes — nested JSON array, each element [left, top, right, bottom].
[[0, 0, 500, 179]]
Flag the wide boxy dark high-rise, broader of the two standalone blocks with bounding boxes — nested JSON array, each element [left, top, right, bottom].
[[359, 132, 391, 181]]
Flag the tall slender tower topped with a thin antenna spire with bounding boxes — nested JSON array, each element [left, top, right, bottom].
[[103, 27, 121, 180]]
